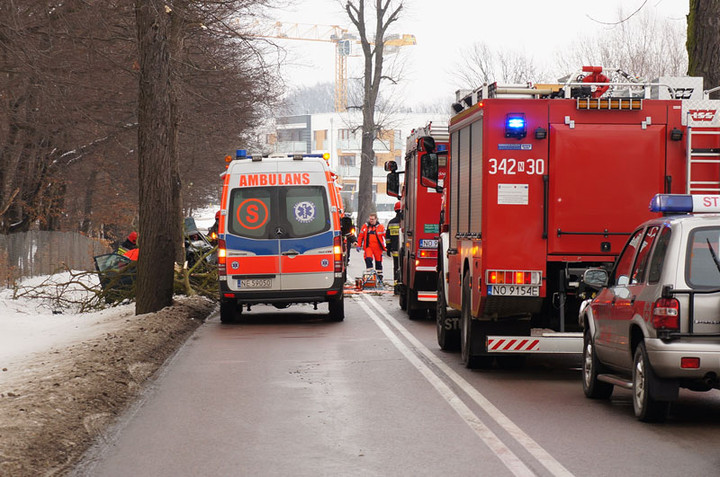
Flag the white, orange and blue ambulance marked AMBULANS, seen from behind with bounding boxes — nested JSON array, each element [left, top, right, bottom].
[[218, 149, 350, 323]]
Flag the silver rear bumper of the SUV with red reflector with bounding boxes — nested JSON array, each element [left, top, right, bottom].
[[645, 339, 720, 379]]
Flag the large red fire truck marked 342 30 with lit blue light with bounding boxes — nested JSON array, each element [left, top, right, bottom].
[[422, 67, 720, 367]]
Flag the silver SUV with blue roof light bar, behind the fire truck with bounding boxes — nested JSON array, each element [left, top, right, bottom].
[[580, 194, 720, 421]]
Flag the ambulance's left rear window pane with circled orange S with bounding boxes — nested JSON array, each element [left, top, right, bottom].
[[228, 187, 273, 239]]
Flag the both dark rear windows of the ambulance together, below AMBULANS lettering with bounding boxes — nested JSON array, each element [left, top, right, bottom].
[[228, 186, 330, 239]]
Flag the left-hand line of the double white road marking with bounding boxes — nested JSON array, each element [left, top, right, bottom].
[[359, 300, 535, 477]]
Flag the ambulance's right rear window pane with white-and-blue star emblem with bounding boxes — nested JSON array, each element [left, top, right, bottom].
[[280, 186, 331, 238]]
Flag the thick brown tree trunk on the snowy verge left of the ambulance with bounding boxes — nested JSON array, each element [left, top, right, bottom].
[[135, 0, 179, 314]]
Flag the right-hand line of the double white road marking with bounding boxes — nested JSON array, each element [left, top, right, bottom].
[[361, 295, 573, 477]]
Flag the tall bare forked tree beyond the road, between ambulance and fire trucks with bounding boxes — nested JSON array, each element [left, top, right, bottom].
[[345, 0, 403, 224]]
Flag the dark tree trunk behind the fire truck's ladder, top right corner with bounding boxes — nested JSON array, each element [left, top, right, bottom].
[[687, 0, 720, 98]]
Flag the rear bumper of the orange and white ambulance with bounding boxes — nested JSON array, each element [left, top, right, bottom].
[[220, 278, 345, 305]]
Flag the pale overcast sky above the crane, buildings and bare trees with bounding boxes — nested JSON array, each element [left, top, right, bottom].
[[271, 0, 689, 103]]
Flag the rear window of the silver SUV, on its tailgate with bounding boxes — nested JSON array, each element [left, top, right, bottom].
[[685, 227, 720, 288]]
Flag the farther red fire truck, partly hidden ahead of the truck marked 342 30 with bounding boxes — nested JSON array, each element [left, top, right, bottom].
[[385, 123, 448, 319]]
